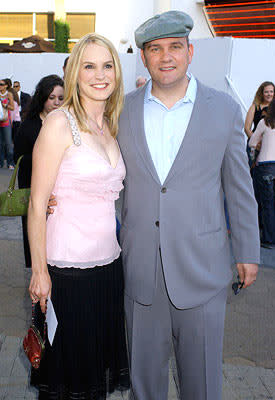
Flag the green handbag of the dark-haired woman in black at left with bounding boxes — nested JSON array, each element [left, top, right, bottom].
[[0, 156, 31, 217]]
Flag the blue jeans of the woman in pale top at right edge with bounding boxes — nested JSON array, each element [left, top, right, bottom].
[[254, 163, 275, 244]]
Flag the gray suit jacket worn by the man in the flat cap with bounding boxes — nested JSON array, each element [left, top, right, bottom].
[[118, 82, 260, 309]]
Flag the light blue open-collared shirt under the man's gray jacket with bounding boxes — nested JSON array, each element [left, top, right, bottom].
[[144, 74, 197, 184]]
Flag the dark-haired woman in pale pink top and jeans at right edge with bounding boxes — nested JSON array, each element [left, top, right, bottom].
[[249, 100, 275, 248]]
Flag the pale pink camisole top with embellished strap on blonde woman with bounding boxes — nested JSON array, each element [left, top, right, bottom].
[[47, 109, 125, 268]]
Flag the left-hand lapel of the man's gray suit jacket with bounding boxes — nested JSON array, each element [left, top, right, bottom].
[[128, 85, 160, 184]]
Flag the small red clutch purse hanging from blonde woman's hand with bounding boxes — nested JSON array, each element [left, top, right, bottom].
[[23, 303, 46, 369]]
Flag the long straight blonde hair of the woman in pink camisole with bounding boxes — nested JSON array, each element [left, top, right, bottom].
[[63, 33, 124, 137]]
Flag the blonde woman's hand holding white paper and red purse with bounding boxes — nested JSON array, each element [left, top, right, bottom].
[[29, 270, 52, 313]]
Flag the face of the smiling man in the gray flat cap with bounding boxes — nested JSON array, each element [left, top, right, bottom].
[[141, 37, 193, 88]]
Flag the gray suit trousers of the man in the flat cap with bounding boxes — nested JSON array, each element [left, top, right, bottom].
[[125, 250, 227, 400]]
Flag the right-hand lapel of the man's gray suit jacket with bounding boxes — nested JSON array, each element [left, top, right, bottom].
[[164, 81, 210, 185]]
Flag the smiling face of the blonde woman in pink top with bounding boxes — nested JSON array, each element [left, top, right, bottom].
[[78, 43, 116, 102]]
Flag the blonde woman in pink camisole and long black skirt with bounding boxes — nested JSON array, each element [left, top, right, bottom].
[[28, 34, 129, 400]]
